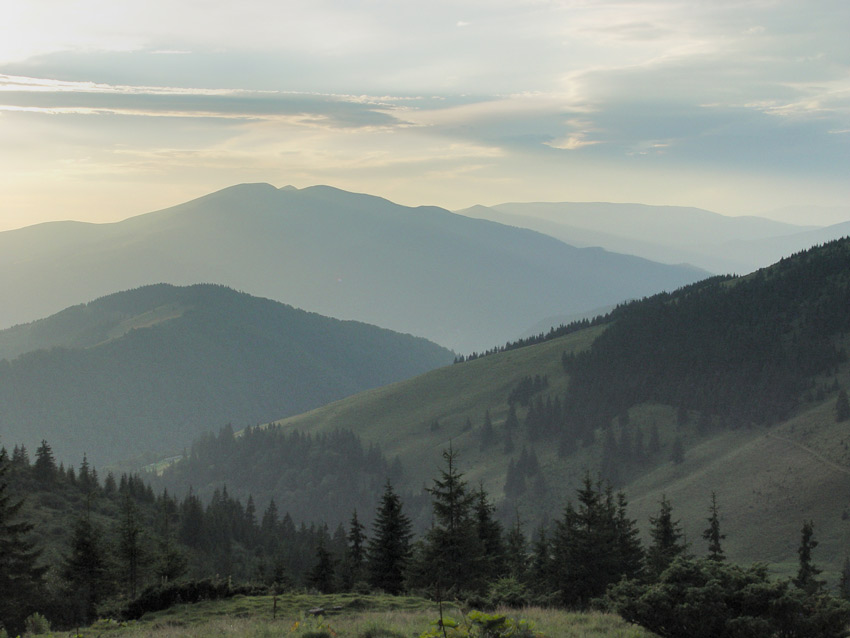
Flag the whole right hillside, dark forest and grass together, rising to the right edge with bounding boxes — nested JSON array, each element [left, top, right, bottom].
[[232, 240, 850, 581]]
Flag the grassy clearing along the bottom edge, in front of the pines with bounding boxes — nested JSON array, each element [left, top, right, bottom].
[[34, 594, 654, 638]]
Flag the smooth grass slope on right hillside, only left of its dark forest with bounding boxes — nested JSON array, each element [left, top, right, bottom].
[[272, 329, 599, 497]]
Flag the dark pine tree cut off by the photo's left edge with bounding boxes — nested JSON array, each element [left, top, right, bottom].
[[0, 460, 46, 636]]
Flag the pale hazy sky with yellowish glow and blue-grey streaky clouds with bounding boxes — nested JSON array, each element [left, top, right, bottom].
[[0, 0, 850, 229]]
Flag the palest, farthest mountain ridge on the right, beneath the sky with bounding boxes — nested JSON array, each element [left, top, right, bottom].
[[457, 202, 850, 274]]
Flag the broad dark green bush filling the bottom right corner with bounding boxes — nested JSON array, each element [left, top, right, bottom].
[[608, 558, 850, 638]]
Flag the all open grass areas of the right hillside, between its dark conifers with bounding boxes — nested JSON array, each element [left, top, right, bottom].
[[270, 328, 850, 583]]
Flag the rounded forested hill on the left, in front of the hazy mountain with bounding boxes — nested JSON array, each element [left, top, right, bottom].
[[0, 284, 454, 465]]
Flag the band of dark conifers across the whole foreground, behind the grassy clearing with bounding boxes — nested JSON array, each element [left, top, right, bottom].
[[0, 442, 850, 638]]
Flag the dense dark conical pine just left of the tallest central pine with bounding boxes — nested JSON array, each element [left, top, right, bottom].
[[366, 480, 413, 594]]
